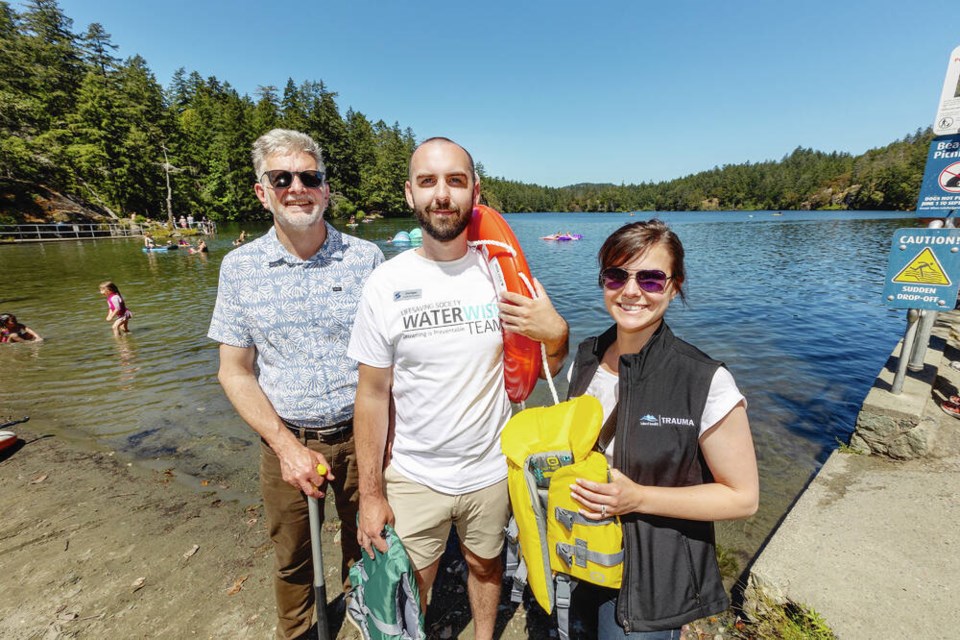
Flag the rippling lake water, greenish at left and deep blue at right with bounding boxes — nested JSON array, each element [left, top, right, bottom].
[[0, 212, 918, 556]]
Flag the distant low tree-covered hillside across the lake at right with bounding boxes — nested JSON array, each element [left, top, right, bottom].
[[484, 128, 933, 212]]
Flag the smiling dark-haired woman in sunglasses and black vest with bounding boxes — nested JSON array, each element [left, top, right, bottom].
[[569, 220, 759, 640]]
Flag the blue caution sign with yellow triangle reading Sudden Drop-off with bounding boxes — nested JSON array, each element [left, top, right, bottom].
[[883, 229, 960, 311]]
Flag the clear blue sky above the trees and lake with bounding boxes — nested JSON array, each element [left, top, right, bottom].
[[54, 0, 960, 186]]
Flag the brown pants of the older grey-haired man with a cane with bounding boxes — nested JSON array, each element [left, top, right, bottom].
[[260, 434, 360, 640]]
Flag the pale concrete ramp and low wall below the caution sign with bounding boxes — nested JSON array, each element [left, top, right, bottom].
[[744, 311, 960, 640]]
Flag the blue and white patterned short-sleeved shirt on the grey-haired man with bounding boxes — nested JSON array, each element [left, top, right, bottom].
[[207, 223, 383, 430]]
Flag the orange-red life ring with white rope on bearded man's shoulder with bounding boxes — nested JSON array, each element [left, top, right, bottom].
[[467, 204, 541, 402]]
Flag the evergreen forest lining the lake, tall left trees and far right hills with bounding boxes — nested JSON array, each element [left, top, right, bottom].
[[0, 0, 933, 224]]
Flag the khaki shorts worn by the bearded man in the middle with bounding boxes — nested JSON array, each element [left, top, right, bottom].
[[383, 465, 510, 571]]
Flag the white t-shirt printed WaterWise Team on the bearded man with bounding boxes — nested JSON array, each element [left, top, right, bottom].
[[347, 249, 511, 495]]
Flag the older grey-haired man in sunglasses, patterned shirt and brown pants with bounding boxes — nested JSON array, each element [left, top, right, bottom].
[[208, 129, 383, 639]]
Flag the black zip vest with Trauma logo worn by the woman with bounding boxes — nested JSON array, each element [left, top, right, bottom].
[[568, 323, 729, 632]]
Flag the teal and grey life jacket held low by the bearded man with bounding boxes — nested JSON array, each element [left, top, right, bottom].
[[347, 525, 426, 640]]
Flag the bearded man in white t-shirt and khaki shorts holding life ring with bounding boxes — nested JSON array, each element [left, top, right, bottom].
[[347, 138, 568, 640]]
